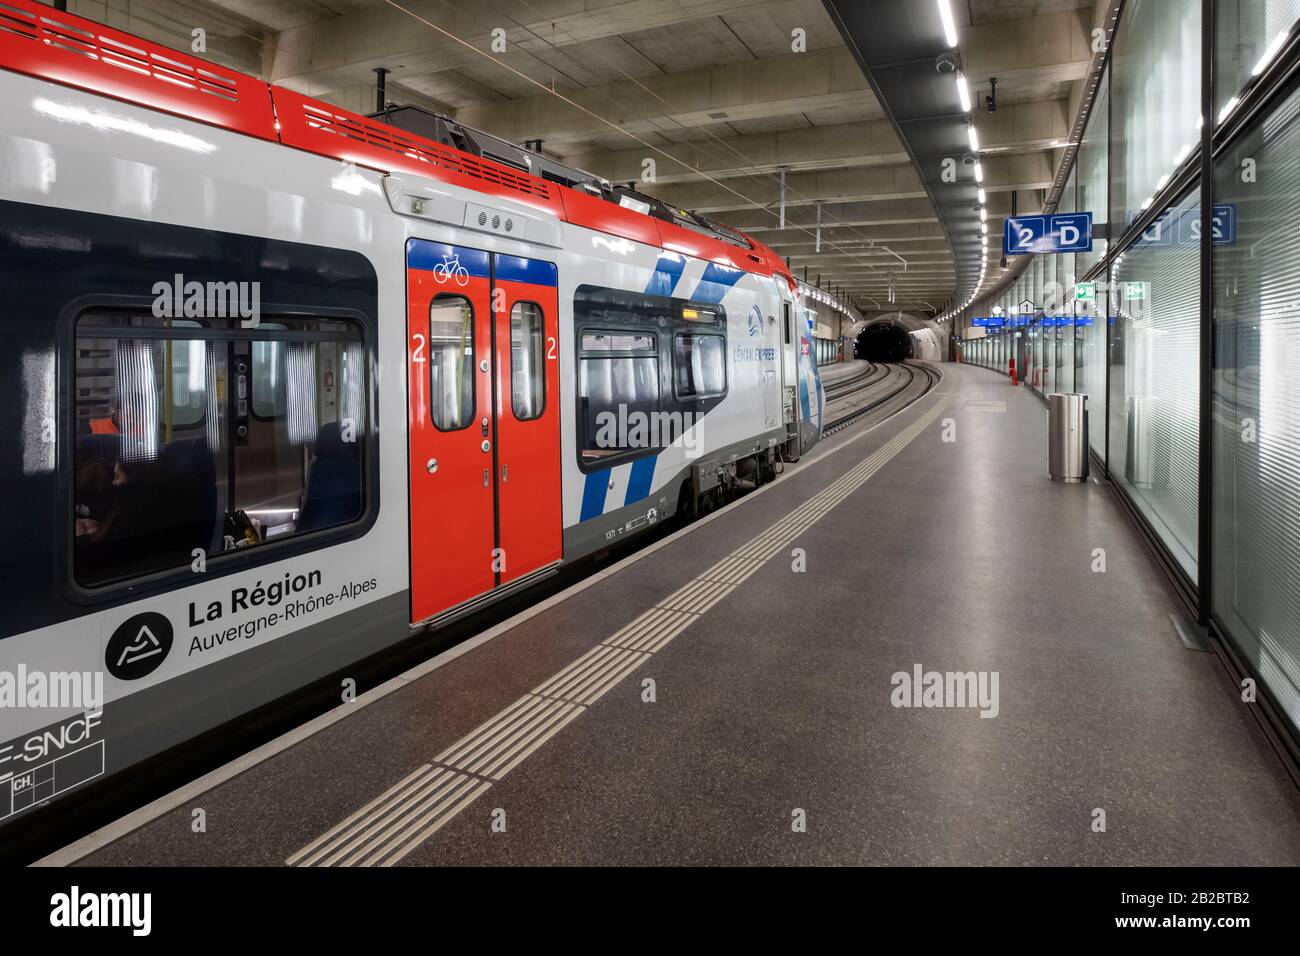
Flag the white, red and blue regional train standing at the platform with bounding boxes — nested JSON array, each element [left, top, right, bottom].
[[0, 0, 824, 839]]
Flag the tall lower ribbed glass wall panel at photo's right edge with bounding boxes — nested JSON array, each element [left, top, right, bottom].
[[1212, 78, 1300, 726]]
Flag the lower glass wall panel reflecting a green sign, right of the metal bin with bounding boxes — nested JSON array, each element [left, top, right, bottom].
[[1109, 190, 1200, 579]]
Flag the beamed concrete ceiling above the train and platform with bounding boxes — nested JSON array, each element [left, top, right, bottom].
[[69, 0, 1112, 312]]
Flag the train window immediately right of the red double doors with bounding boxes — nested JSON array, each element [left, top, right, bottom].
[[577, 332, 659, 466]]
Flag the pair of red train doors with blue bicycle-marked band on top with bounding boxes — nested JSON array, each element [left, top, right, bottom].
[[407, 239, 562, 622]]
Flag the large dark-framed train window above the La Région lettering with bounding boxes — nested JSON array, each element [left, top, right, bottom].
[[72, 312, 369, 587]]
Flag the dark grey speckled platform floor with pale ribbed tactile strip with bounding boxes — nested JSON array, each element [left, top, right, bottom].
[[52, 365, 1300, 865]]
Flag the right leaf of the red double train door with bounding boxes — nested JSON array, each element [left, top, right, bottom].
[[493, 255, 563, 584]]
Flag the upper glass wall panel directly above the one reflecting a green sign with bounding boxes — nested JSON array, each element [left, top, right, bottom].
[[1110, 0, 1201, 235]]
